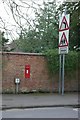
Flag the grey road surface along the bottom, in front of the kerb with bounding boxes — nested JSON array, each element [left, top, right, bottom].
[[2, 107, 78, 118]]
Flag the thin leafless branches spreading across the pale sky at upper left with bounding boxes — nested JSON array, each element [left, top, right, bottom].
[[0, 0, 43, 38]]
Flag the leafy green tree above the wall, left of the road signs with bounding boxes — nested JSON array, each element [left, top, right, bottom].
[[13, 1, 58, 52]]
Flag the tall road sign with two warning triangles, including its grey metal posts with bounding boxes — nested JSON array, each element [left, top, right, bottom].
[[58, 14, 70, 95]]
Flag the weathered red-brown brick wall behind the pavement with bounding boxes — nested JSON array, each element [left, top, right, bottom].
[[2, 52, 77, 93]]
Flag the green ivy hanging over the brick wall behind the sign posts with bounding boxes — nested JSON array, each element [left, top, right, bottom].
[[45, 49, 78, 74]]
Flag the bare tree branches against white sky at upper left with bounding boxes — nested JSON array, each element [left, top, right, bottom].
[[0, 0, 41, 40]]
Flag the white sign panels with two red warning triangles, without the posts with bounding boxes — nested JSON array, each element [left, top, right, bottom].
[[58, 14, 70, 54]]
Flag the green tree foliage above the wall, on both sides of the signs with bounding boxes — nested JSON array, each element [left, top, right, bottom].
[[12, 1, 80, 53]]
